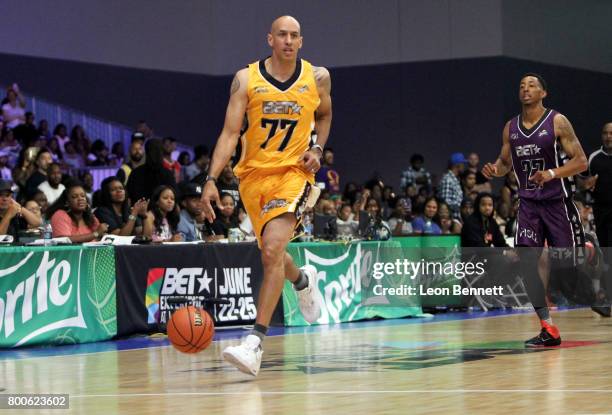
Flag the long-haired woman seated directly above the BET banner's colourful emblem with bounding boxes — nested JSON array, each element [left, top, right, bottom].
[[143, 185, 182, 242]]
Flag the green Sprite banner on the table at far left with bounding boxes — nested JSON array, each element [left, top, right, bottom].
[[0, 246, 117, 347]]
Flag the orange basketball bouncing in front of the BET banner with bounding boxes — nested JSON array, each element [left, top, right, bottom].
[[167, 305, 215, 353]]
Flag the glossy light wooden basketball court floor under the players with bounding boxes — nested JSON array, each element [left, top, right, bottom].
[[0, 309, 612, 415]]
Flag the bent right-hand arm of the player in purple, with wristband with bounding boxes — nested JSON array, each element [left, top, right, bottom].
[[529, 114, 588, 185]]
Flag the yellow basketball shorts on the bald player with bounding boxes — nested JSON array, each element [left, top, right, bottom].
[[239, 167, 314, 246]]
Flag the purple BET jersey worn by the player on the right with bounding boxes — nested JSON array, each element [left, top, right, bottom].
[[509, 109, 573, 200]]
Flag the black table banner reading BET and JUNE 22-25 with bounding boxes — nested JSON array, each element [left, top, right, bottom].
[[116, 243, 263, 335]]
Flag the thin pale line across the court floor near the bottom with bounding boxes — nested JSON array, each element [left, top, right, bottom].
[[70, 389, 612, 399]]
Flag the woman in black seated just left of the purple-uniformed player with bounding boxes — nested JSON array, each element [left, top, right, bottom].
[[461, 193, 508, 247]]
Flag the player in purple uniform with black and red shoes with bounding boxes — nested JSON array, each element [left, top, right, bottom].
[[482, 73, 587, 347]]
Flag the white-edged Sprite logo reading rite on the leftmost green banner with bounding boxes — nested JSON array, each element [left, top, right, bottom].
[[0, 251, 87, 347]]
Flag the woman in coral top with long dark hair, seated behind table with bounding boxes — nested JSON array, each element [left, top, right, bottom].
[[46, 182, 108, 243]]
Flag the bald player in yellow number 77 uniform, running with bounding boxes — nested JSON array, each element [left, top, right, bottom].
[[202, 16, 332, 376]]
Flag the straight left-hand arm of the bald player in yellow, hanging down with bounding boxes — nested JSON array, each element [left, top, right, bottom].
[[202, 68, 248, 222]]
